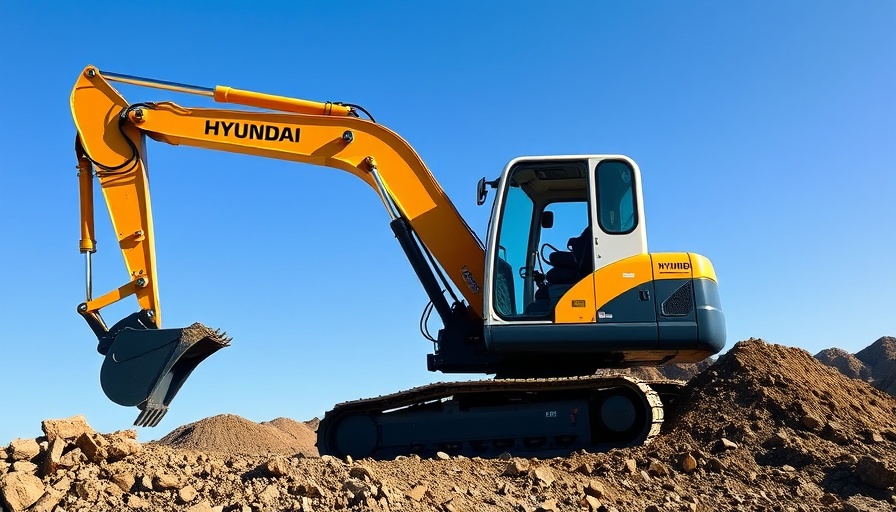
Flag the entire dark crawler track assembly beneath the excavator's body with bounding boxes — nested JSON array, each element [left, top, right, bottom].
[[317, 375, 678, 459]]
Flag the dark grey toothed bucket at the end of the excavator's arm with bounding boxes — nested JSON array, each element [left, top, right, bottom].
[[100, 323, 230, 427]]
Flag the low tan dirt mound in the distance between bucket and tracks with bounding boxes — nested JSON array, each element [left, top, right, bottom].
[[157, 414, 317, 455]]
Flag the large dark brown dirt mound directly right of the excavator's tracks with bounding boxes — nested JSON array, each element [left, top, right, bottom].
[[668, 339, 896, 440]]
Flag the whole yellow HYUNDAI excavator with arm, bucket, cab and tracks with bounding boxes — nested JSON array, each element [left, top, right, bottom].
[[71, 66, 726, 458]]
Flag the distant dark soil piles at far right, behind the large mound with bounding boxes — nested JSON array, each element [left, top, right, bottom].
[[815, 336, 896, 396]]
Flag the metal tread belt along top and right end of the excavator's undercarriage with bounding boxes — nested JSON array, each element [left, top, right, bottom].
[[319, 375, 671, 454]]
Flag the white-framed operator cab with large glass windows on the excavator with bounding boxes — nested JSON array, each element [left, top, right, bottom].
[[486, 156, 647, 324]]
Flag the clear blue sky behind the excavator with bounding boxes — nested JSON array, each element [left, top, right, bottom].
[[0, 0, 896, 443]]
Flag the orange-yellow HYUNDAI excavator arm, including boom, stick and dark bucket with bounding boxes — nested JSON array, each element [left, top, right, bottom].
[[71, 66, 485, 425]]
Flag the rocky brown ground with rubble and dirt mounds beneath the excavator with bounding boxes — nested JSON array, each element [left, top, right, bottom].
[[0, 338, 896, 512]]
